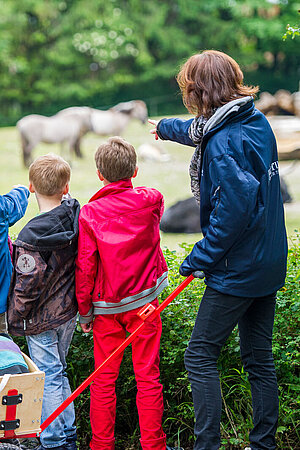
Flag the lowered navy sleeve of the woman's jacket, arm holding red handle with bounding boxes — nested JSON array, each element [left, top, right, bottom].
[[181, 154, 259, 275]]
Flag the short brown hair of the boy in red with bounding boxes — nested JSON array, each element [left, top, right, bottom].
[[95, 136, 136, 182]]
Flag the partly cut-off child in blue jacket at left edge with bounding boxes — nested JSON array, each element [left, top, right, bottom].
[[0, 185, 29, 333]]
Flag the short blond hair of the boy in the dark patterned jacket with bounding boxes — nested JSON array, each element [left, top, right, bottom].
[[29, 153, 71, 197]]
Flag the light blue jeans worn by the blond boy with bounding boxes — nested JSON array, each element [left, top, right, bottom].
[[26, 317, 76, 448]]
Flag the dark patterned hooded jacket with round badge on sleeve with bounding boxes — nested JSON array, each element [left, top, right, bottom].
[[8, 199, 80, 336]]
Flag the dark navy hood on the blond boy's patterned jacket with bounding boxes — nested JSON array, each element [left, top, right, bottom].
[[15, 199, 80, 250]]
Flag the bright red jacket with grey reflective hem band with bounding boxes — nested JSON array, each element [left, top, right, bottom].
[[76, 179, 168, 323]]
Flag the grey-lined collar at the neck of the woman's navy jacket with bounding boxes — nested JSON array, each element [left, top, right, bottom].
[[203, 96, 254, 134]]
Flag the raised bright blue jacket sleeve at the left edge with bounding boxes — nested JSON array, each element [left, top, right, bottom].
[[0, 186, 30, 226]]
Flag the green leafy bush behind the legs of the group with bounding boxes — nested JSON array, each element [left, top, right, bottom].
[[14, 238, 300, 450]]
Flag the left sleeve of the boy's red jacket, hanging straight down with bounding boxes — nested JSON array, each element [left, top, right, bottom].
[[75, 211, 99, 323]]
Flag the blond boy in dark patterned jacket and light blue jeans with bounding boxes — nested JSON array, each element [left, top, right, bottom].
[[8, 154, 80, 450]]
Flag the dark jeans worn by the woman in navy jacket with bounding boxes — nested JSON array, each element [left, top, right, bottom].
[[185, 287, 278, 450]]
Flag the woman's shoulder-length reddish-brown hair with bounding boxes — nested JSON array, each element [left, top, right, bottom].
[[177, 50, 259, 117]]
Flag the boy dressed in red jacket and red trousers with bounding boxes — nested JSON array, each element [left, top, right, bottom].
[[76, 137, 176, 450]]
